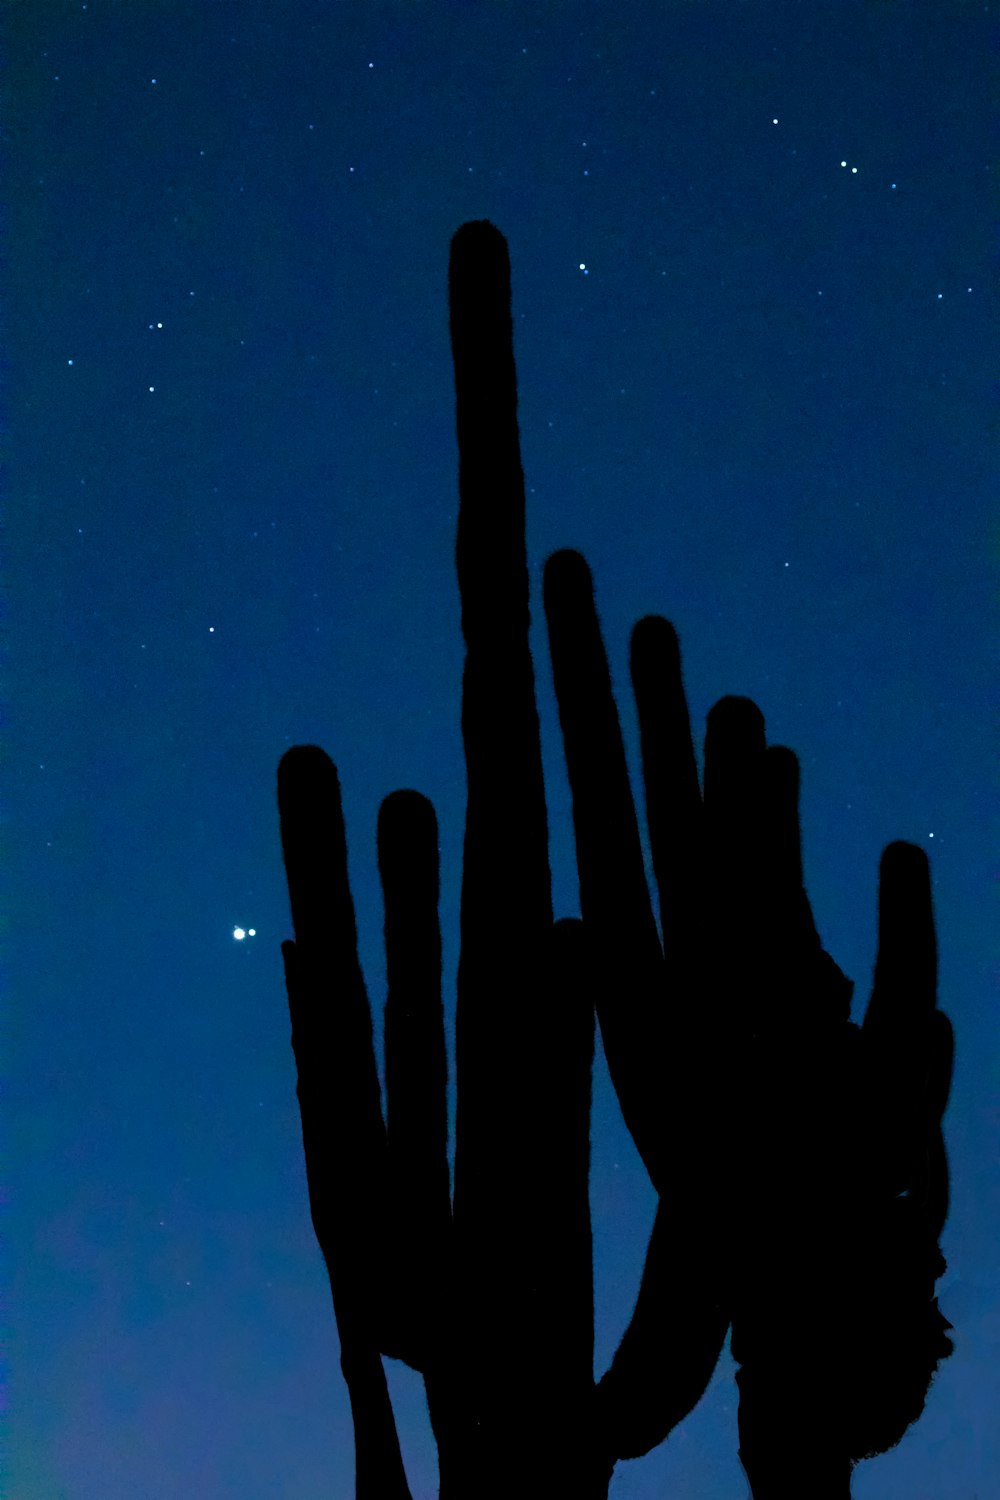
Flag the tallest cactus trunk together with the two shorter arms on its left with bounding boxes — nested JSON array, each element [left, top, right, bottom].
[[279, 228, 610, 1500]]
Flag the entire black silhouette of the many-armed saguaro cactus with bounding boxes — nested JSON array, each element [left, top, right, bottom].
[[279, 224, 951, 1500]]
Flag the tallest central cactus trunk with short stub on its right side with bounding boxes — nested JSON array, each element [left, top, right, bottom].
[[442, 222, 594, 1500]]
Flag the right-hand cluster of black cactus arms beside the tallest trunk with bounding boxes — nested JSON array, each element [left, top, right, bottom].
[[546, 552, 952, 1500]]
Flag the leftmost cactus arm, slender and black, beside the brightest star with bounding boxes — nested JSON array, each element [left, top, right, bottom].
[[277, 746, 411, 1500]]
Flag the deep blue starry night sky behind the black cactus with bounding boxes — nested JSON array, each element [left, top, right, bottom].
[[3, 0, 1000, 1500]]
